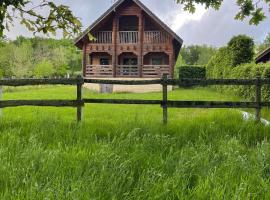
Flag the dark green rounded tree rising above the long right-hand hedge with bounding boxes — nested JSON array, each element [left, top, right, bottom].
[[228, 35, 255, 67]]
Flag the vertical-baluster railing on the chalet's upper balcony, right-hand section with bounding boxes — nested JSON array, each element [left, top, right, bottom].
[[143, 31, 170, 44]]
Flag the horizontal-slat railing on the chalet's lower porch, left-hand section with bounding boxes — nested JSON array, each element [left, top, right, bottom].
[[85, 65, 113, 77]]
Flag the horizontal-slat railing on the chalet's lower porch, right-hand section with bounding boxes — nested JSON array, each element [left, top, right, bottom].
[[142, 65, 171, 78]]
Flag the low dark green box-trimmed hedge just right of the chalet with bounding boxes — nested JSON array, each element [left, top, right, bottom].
[[179, 66, 206, 79]]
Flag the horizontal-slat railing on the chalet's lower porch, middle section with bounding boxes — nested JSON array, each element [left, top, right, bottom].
[[116, 65, 140, 77]]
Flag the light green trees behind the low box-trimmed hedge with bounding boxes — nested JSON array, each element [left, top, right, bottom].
[[180, 45, 216, 65]]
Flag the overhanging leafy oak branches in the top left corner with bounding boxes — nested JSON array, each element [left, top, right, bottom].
[[0, 0, 82, 38]]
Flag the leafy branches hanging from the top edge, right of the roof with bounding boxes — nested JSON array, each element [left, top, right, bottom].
[[176, 0, 270, 25]]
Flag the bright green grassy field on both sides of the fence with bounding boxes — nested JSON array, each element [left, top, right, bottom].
[[0, 86, 270, 199]]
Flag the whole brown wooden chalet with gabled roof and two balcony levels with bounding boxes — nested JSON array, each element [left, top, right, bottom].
[[75, 0, 183, 78]]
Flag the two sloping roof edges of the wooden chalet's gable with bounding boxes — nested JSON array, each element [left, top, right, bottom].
[[74, 0, 183, 45]]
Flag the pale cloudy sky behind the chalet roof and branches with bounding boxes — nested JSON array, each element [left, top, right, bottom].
[[5, 0, 270, 47]]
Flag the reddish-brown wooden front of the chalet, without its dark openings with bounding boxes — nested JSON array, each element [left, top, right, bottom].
[[83, 0, 175, 78]]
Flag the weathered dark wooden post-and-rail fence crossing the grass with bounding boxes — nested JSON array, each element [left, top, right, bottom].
[[0, 75, 270, 124]]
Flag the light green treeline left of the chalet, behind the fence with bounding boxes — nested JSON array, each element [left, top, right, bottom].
[[0, 36, 81, 78]]
